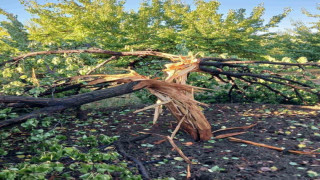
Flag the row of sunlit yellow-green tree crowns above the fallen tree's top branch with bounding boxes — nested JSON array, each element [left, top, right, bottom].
[[19, 0, 290, 58]]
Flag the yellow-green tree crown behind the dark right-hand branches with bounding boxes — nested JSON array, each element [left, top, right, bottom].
[[182, 0, 290, 58]]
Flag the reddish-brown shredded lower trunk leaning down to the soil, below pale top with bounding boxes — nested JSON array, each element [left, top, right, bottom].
[[135, 80, 212, 140]]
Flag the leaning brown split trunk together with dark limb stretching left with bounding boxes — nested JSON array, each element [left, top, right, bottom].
[[0, 77, 212, 140]]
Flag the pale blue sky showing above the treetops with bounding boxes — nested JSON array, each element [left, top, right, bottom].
[[0, 0, 320, 31]]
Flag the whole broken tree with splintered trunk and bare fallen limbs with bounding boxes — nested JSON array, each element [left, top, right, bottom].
[[0, 50, 320, 140]]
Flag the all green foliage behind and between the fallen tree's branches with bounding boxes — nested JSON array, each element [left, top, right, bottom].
[[0, 0, 320, 104]]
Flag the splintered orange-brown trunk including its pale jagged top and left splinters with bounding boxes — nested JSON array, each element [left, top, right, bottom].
[[72, 54, 212, 140]]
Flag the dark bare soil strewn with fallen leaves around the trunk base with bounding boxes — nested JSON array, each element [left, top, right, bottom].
[[2, 104, 320, 180]]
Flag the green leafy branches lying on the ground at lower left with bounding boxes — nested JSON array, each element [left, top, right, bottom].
[[0, 112, 141, 180]]
